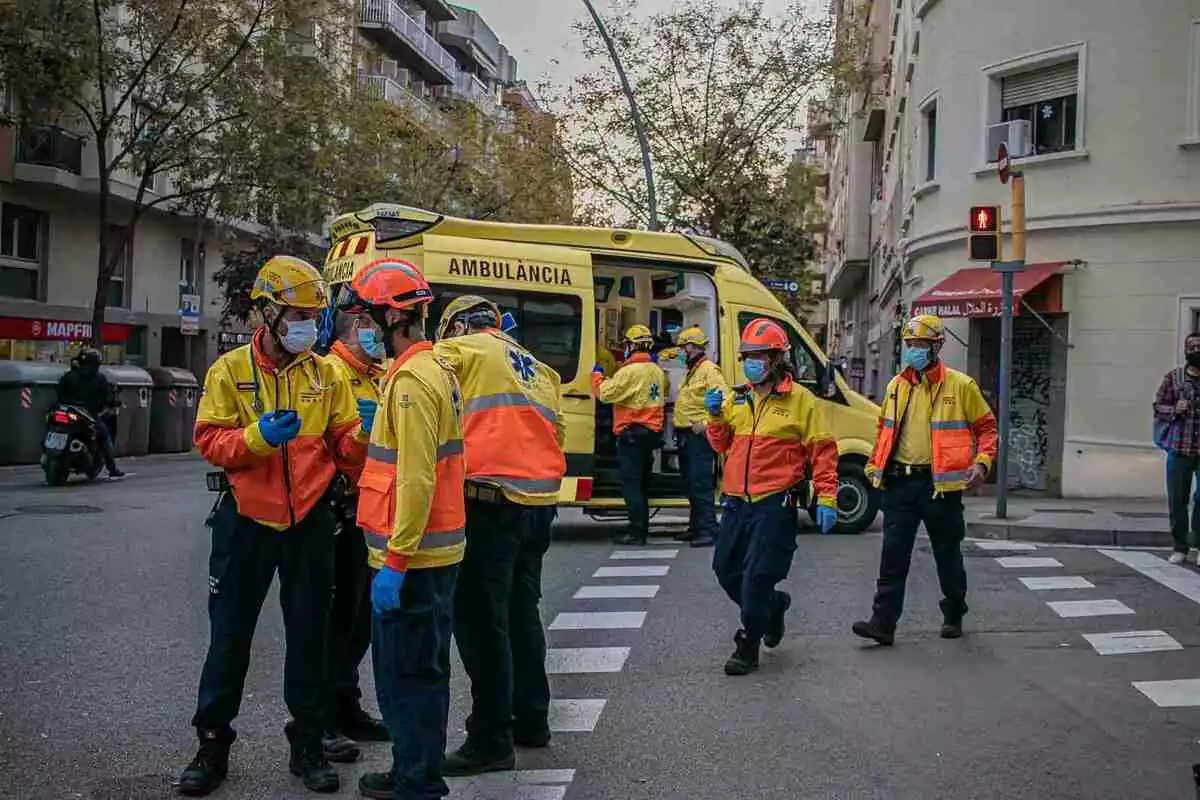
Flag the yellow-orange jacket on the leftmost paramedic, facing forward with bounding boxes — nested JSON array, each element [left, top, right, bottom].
[[193, 329, 367, 530]]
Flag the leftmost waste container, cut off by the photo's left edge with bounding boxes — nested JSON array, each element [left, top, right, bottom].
[[0, 360, 67, 464]]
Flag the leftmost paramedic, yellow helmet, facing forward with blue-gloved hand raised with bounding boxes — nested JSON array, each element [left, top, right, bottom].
[[179, 255, 370, 796]]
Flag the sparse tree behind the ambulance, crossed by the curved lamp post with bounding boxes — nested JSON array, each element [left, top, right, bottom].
[[545, 0, 863, 305]]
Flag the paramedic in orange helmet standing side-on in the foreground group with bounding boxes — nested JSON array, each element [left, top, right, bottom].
[[342, 258, 466, 798]]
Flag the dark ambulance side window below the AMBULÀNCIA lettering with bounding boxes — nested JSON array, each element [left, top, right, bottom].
[[426, 285, 583, 385]]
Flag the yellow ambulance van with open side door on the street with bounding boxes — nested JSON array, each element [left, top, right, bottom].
[[324, 204, 878, 533]]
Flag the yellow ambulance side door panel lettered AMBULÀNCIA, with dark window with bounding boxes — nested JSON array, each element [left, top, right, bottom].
[[420, 235, 596, 504]]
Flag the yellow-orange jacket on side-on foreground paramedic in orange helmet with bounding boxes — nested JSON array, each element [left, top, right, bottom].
[[358, 342, 467, 570]]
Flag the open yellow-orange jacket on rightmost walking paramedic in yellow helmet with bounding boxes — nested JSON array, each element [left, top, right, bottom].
[[866, 361, 1000, 492]]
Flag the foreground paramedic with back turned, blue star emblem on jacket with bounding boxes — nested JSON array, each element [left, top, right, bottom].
[[434, 295, 566, 776]]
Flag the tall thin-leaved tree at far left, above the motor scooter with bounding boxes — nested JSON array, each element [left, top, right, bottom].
[[0, 0, 348, 341]]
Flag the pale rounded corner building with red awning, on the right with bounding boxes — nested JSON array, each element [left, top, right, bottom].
[[814, 0, 1200, 497]]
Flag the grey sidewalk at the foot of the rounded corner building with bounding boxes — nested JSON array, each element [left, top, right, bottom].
[[965, 493, 1171, 547]]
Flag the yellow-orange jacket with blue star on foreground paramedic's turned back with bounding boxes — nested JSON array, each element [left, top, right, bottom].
[[434, 330, 566, 505]]
